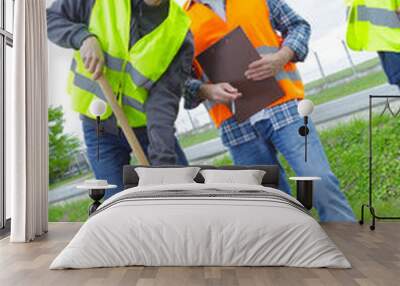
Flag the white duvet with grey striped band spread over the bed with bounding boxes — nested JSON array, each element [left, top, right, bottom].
[[50, 184, 351, 269]]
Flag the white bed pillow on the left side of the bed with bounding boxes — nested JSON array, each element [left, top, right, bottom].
[[135, 167, 200, 186]]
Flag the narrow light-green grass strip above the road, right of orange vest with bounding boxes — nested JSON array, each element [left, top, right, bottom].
[[308, 72, 387, 105]]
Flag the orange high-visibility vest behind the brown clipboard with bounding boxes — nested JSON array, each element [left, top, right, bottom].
[[184, 0, 304, 127]]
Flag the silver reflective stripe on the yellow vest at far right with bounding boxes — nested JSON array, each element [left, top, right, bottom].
[[357, 6, 400, 28]]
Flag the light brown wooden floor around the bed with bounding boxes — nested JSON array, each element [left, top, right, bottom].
[[0, 223, 400, 286]]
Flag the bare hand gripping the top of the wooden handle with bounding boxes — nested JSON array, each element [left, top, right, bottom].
[[80, 36, 104, 80]]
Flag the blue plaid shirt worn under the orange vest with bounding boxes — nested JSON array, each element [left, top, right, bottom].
[[184, 0, 311, 146]]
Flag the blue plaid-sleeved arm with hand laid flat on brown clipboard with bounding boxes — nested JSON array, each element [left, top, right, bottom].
[[245, 0, 311, 81]]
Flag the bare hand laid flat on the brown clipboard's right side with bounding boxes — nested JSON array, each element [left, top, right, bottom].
[[244, 47, 294, 81]]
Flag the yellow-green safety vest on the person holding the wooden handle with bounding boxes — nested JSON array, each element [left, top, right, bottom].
[[68, 0, 190, 127]]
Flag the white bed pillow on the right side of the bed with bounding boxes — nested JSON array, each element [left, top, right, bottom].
[[200, 170, 266, 185]]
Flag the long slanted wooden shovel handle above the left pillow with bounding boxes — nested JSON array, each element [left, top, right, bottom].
[[97, 76, 150, 166]]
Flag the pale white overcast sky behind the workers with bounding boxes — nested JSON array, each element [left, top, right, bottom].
[[47, 0, 375, 137]]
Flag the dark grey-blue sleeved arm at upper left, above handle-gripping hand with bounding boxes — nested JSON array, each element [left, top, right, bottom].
[[47, 0, 95, 50]]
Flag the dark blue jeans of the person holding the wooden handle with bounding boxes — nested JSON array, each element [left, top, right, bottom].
[[82, 121, 188, 199]]
